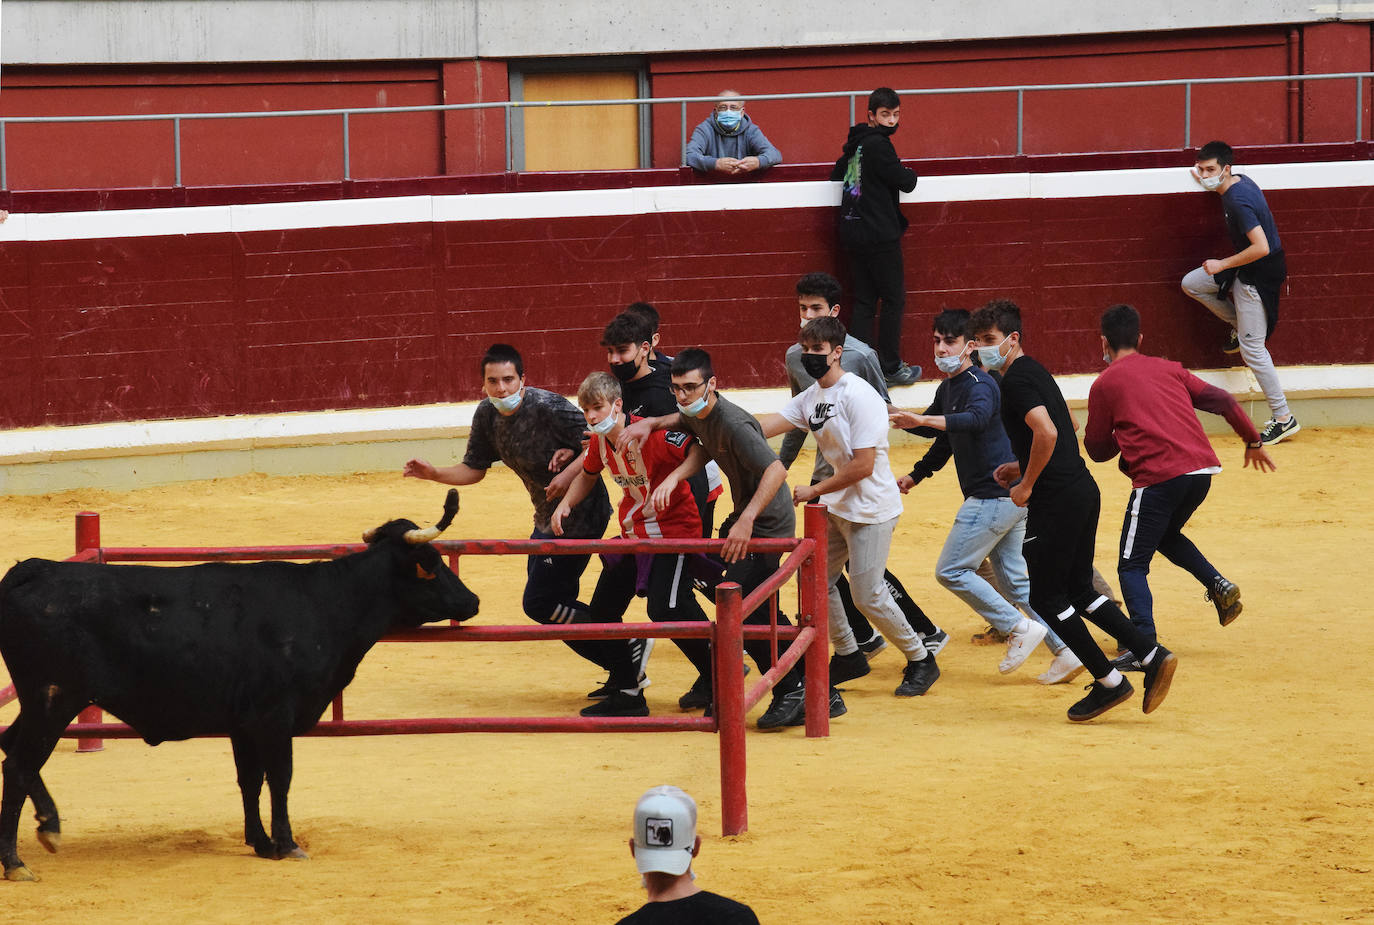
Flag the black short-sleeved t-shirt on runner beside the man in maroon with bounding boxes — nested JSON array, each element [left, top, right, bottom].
[[1002, 355, 1088, 504]]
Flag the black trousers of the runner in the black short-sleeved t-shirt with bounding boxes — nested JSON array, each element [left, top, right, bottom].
[[1021, 474, 1154, 678]]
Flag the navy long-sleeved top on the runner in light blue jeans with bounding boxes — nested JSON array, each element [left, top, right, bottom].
[[911, 366, 1015, 498]]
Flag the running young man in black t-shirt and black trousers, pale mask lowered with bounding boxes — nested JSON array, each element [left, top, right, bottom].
[[969, 300, 1178, 723]]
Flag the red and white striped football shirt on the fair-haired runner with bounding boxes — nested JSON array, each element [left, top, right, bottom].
[[583, 415, 701, 539]]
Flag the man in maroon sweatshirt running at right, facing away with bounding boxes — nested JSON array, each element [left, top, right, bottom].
[[1083, 305, 1274, 648]]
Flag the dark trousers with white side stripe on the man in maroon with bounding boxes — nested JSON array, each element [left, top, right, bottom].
[[1117, 476, 1219, 642]]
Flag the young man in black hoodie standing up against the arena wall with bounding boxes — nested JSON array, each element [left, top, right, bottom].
[[830, 87, 921, 385]]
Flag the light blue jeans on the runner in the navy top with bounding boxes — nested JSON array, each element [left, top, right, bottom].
[[936, 498, 1063, 654]]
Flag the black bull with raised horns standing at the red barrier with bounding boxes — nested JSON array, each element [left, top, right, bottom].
[[0, 491, 477, 880]]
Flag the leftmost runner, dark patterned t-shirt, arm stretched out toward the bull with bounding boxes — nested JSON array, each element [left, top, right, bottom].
[[404, 344, 649, 714]]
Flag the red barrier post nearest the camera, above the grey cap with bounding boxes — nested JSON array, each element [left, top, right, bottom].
[[712, 581, 749, 836]]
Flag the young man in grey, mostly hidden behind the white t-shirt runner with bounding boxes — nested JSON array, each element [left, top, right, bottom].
[[778, 274, 949, 658]]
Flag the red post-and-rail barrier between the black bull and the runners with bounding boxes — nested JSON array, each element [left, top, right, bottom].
[[8, 504, 830, 834]]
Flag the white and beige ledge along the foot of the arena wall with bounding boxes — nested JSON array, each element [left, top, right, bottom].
[[0, 366, 1374, 495]]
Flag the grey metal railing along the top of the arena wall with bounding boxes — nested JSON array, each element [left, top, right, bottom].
[[0, 71, 1374, 190]]
